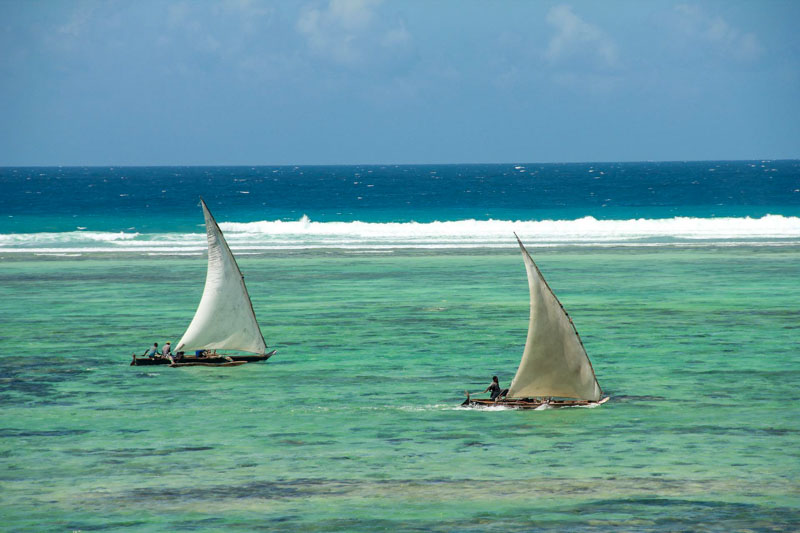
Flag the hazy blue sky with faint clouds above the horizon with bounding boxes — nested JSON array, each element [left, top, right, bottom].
[[0, 0, 800, 165]]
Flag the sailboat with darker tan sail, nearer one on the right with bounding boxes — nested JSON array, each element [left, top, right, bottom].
[[462, 233, 608, 409]]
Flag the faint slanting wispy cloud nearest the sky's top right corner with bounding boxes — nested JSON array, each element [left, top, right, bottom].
[[675, 4, 764, 61]]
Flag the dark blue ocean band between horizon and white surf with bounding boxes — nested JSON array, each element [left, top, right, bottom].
[[0, 160, 800, 234]]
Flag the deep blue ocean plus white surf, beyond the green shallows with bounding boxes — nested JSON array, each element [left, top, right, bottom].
[[0, 160, 800, 253]]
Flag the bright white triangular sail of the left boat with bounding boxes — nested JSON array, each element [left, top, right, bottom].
[[176, 200, 267, 354]]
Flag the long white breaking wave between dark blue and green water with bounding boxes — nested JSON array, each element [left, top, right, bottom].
[[0, 215, 800, 255]]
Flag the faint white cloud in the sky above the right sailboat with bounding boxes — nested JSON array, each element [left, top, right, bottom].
[[545, 4, 619, 67]]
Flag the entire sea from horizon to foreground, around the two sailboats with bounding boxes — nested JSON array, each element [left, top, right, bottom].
[[0, 161, 800, 532]]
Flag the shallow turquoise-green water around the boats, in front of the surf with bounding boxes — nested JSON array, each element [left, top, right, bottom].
[[0, 247, 800, 531]]
